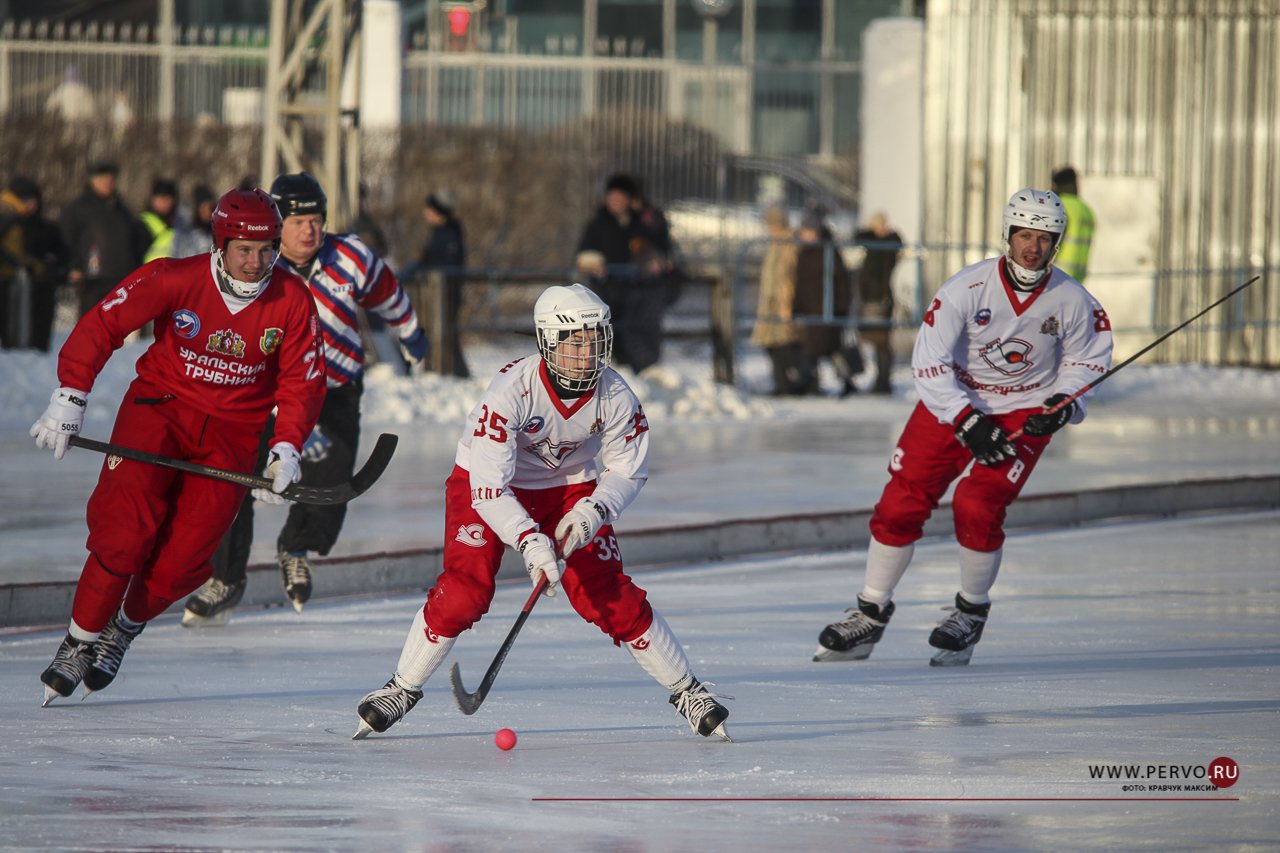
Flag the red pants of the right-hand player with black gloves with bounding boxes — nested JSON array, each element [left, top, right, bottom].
[[870, 403, 1050, 551]]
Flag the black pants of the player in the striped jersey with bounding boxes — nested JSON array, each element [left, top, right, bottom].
[[211, 380, 364, 584]]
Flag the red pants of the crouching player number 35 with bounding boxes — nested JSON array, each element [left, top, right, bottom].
[[422, 467, 653, 643]]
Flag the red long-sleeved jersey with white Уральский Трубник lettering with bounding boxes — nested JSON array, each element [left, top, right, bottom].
[[58, 254, 325, 448]]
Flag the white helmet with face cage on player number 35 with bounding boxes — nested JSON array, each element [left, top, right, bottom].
[[534, 284, 613, 392]]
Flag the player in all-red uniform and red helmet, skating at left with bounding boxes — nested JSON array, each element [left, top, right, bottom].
[[31, 190, 325, 704]]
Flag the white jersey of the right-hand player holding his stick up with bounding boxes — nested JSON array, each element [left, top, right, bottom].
[[911, 257, 1111, 424]]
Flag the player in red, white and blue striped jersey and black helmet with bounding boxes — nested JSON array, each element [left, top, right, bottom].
[[183, 172, 426, 626]]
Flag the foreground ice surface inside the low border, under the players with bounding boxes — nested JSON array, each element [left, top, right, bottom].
[[0, 512, 1280, 852]]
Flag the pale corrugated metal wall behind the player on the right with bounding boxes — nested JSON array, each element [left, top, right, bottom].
[[924, 0, 1280, 366]]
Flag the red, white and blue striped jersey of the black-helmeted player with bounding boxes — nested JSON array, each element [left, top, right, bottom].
[[276, 234, 417, 387]]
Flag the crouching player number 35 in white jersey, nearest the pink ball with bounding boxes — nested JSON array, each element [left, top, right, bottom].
[[355, 284, 728, 740]]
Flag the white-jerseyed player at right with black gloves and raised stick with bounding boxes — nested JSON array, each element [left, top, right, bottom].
[[814, 190, 1111, 666]]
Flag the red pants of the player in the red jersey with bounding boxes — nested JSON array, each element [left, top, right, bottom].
[[72, 379, 266, 631]]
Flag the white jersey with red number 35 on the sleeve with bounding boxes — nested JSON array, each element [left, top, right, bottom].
[[457, 356, 649, 547]]
